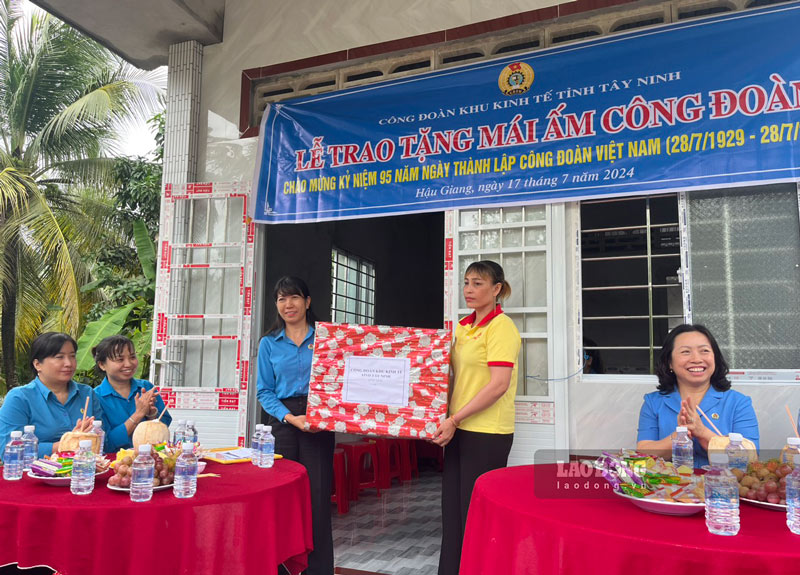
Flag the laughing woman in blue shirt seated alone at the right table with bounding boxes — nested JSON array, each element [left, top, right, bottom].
[[636, 324, 758, 467]]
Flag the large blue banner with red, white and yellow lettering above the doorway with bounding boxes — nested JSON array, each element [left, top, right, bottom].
[[253, 3, 800, 223]]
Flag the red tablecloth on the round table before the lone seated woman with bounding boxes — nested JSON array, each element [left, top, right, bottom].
[[461, 465, 800, 575]]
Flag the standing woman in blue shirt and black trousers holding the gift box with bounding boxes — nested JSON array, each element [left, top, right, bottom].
[[258, 276, 336, 575]]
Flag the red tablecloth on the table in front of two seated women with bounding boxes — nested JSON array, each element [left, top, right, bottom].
[[0, 460, 312, 575]]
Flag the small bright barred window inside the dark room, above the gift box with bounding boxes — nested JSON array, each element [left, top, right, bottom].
[[331, 248, 375, 324]]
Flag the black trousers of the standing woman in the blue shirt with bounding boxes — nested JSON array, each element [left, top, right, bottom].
[[266, 397, 336, 575]]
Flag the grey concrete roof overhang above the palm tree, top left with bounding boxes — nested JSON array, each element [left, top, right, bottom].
[[31, 0, 225, 70]]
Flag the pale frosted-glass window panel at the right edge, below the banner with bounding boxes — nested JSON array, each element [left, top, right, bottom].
[[687, 183, 800, 369]]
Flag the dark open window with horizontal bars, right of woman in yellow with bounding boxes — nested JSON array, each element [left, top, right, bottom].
[[581, 194, 683, 375]]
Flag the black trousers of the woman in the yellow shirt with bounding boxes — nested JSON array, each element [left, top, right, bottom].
[[439, 429, 514, 575]]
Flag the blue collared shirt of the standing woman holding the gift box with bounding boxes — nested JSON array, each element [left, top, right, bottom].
[[257, 326, 314, 421]]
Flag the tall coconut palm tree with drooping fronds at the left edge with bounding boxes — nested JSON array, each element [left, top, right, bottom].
[[0, 0, 164, 388]]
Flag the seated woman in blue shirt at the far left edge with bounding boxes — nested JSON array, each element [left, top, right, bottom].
[[0, 332, 103, 457]]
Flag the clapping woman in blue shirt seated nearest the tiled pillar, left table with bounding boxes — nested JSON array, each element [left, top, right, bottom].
[[92, 335, 172, 453]]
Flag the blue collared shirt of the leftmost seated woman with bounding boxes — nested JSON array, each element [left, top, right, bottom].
[[0, 377, 104, 457]]
